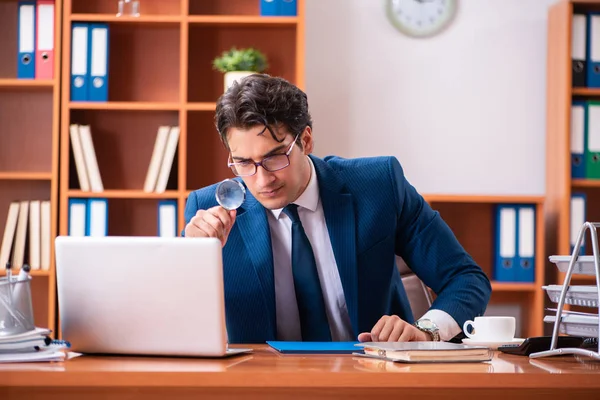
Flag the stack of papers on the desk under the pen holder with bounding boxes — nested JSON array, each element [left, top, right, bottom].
[[0, 328, 69, 363]]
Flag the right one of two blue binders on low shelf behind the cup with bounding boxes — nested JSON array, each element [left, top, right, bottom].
[[515, 205, 536, 282]]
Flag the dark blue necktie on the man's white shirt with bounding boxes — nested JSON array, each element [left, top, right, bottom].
[[283, 204, 331, 342]]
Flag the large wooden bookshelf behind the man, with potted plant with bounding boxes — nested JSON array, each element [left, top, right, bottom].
[[59, 0, 304, 236]]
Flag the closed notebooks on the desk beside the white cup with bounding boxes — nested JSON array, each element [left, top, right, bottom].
[[355, 342, 493, 363]]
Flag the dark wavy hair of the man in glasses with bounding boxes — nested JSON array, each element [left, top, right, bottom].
[[215, 74, 312, 148]]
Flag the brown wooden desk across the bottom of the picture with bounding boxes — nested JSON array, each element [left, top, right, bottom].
[[0, 346, 600, 400]]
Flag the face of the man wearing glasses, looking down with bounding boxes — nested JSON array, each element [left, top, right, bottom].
[[227, 126, 313, 209]]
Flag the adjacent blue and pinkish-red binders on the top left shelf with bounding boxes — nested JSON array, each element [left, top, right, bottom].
[[17, 0, 55, 79]]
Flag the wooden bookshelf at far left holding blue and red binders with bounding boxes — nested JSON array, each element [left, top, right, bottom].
[[0, 0, 62, 331]]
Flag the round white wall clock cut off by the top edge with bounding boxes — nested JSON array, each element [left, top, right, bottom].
[[386, 0, 458, 37]]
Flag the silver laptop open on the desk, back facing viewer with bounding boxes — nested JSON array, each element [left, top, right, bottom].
[[55, 236, 251, 357]]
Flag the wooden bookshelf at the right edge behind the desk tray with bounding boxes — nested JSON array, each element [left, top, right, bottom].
[[546, 0, 600, 296]]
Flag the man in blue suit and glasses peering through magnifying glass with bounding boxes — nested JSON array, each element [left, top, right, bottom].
[[183, 74, 491, 343]]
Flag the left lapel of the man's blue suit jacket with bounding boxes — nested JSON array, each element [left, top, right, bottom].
[[235, 191, 277, 338]]
